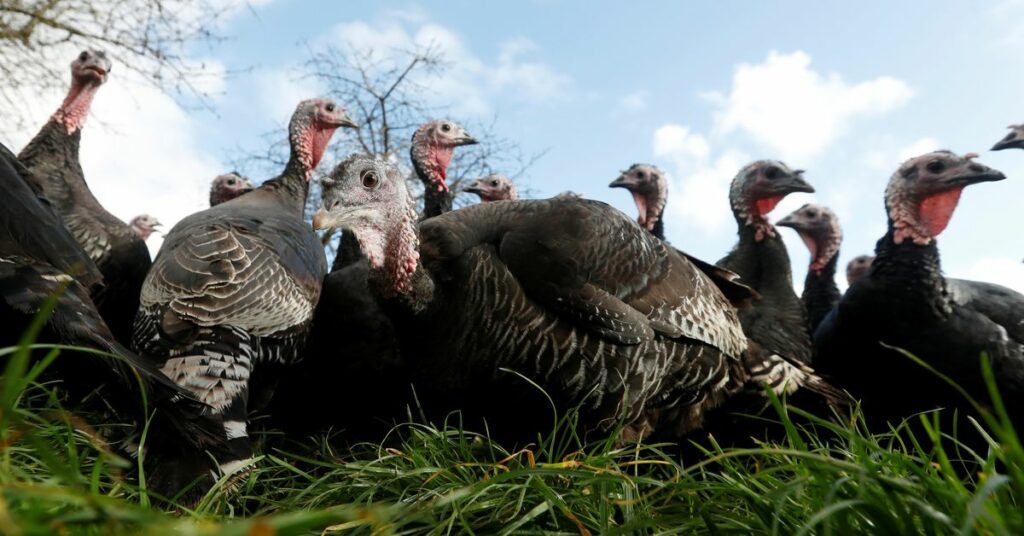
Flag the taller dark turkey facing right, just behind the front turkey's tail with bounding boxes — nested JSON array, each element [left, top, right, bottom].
[[718, 160, 814, 364]]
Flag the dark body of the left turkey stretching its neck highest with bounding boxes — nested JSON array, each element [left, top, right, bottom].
[[18, 120, 151, 343]]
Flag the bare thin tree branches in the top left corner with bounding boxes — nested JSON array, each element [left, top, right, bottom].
[[0, 0, 240, 133]]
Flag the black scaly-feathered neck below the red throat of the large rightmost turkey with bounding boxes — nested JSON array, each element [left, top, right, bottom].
[[865, 219, 951, 318]]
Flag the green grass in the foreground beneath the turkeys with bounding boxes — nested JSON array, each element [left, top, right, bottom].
[[0, 338, 1024, 535]]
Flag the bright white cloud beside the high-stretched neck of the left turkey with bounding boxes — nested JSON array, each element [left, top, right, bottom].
[[10, 48, 224, 254]]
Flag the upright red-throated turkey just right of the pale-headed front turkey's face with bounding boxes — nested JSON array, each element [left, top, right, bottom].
[[409, 119, 477, 217]]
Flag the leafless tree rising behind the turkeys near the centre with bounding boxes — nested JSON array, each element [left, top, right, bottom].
[[234, 39, 543, 252]]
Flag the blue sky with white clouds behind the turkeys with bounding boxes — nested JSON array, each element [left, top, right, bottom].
[[0, 0, 1024, 292]]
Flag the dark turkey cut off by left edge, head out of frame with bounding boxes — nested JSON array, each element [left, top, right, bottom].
[[0, 146, 213, 496]]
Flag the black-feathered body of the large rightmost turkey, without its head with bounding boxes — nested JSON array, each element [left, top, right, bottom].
[[814, 232, 1024, 420]]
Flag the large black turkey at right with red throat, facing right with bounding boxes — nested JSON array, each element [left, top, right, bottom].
[[814, 151, 1024, 428]]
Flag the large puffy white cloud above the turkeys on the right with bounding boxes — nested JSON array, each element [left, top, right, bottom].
[[703, 50, 913, 165]]
